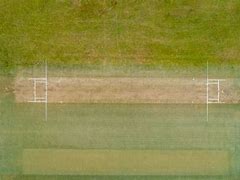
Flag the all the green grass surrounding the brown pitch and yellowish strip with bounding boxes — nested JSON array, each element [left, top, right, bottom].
[[0, 0, 240, 180]]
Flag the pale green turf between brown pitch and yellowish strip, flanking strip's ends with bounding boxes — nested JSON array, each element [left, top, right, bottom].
[[1, 95, 240, 174]]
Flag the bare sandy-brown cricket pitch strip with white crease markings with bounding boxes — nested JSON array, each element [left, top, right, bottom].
[[15, 77, 240, 103]]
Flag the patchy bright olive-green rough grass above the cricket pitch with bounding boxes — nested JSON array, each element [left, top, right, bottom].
[[0, 0, 240, 70]]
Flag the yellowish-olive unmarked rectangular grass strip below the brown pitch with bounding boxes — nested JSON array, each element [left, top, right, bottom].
[[23, 149, 231, 175]]
